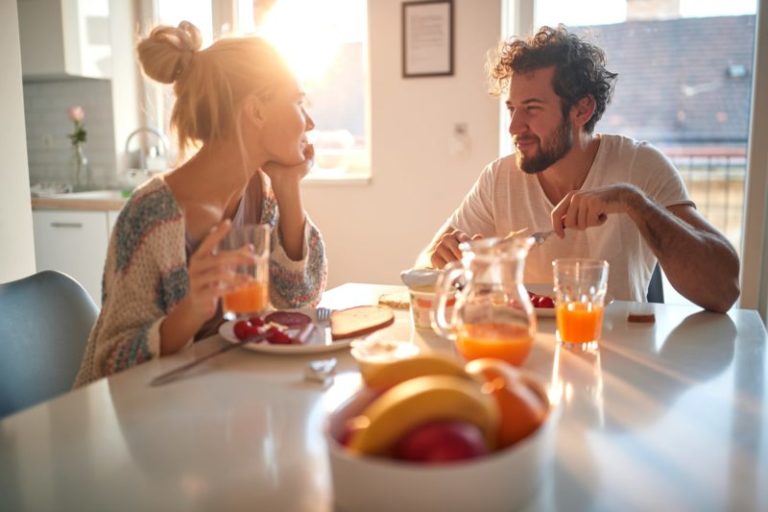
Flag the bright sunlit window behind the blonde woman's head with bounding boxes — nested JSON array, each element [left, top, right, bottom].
[[148, 0, 370, 180]]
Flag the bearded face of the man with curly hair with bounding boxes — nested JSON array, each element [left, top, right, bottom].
[[507, 67, 573, 174]]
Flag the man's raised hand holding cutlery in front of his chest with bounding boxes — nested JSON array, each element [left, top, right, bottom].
[[551, 183, 641, 238]]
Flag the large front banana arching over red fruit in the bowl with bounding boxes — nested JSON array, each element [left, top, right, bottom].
[[347, 375, 500, 455]]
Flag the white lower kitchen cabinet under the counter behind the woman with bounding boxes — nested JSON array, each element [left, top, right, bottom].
[[32, 210, 111, 306]]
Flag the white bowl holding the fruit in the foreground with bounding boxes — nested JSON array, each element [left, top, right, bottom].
[[325, 379, 558, 512]]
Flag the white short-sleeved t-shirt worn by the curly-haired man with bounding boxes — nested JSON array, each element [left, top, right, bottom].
[[448, 135, 695, 302]]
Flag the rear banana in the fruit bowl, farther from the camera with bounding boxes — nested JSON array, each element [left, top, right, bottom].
[[365, 354, 471, 389]]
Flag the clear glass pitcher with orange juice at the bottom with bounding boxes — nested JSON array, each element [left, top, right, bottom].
[[432, 237, 536, 365]]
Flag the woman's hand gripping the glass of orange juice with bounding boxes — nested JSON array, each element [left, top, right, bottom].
[[185, 220, 256, 322]]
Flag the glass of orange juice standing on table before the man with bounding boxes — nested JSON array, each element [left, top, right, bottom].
[[552, 258, 608, 346]]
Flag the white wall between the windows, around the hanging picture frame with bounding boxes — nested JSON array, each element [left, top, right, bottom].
[[304, 0, 501, 287]]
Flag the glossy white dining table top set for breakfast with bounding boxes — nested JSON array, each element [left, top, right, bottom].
[[0, 284, 768, 512]]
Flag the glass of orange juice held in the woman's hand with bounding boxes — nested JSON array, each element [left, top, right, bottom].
[[218, 224, 270, 320]]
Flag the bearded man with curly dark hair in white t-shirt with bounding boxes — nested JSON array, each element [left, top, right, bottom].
[[420, 26, 739, 312]]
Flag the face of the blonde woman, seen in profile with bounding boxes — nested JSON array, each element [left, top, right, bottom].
[[261, 80, 315, 166]]
